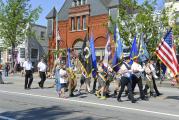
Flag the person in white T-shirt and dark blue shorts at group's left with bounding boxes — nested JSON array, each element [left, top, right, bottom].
[[58, 64, 68, 98]]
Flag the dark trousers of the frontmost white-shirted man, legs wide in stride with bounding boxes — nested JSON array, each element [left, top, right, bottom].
[[117, 77, 134, 101]]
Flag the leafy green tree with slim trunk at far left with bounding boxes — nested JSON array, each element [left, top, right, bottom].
[[0, 0, 42, 66]]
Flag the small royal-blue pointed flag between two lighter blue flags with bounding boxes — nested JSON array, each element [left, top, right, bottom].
[[129, 36, 138, 64]]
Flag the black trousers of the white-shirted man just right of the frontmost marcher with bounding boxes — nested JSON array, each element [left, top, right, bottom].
[[131, 75, 145, 99]]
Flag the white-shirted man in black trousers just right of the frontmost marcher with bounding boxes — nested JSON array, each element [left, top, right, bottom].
[[131, 58, 146, 100]]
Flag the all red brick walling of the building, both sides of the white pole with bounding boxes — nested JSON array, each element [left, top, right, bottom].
[[48, 14, 108, 68]]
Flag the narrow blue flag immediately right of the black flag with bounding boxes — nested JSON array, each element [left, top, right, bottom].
[[90, 33, 97, 78]]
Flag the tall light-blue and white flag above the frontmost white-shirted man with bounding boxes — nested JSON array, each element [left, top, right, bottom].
[[112, 25, 123, 72]]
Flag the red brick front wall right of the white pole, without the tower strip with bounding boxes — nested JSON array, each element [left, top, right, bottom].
[[58, 15, 108, 48]]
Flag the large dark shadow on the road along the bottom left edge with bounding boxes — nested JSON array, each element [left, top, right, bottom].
[[0, 106, 94, 120]]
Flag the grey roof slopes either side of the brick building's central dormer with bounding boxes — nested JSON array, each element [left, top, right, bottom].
[[58, 0, 119, 21]]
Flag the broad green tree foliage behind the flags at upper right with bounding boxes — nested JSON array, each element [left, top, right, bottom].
[[109, 0, 179, 54]]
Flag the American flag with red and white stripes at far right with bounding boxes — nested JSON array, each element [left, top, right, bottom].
[[156, 29, 178, 76]]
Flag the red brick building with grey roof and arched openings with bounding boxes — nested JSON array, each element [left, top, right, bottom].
[[46, 0, 119, 67]]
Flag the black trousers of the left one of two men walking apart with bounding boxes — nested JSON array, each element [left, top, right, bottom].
[[24, 70, 33, 89]]
